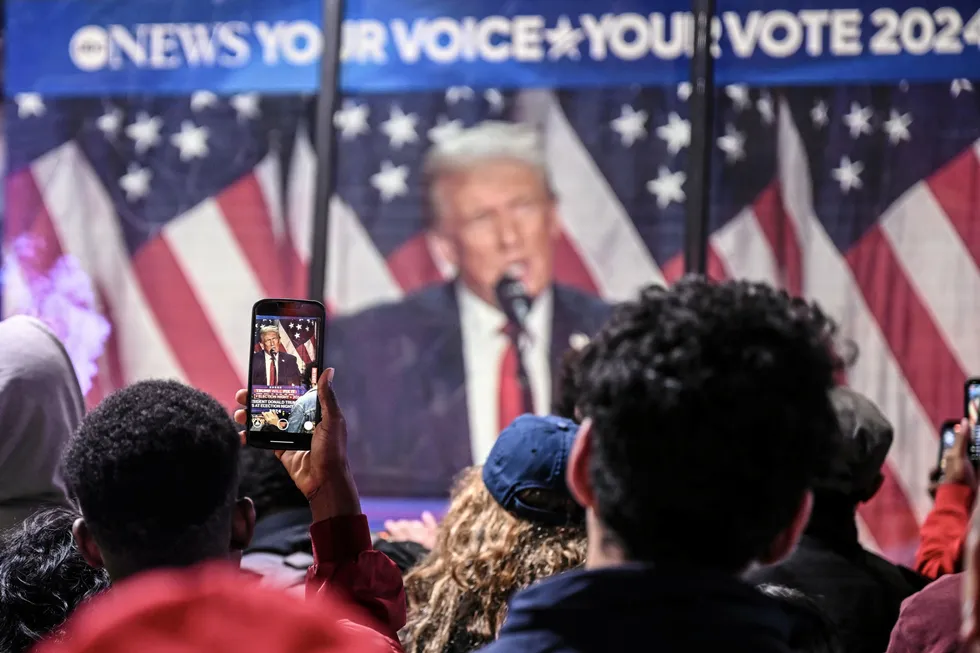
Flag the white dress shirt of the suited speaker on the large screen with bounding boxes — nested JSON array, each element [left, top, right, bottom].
[[457, 284, 554, 465]]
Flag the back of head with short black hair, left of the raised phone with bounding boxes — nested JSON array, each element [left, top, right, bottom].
[[64, 381, 241, 569]]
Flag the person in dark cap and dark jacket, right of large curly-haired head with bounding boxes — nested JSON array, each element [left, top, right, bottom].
[[746, 388, 927, 653]]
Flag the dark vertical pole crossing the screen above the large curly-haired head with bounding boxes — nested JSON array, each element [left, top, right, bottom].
[[684, 0, 715, 274]]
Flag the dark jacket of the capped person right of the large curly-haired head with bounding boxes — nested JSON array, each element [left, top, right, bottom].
[[746, 504, 928, 653]]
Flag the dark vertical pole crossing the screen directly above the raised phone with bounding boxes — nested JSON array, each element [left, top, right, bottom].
[[308, 0, 344, 302]]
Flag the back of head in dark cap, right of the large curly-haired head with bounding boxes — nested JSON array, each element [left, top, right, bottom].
[[814, 387, 895, 505]]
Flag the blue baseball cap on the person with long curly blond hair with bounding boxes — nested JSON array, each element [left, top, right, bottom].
[[483, 414, 585, 525]]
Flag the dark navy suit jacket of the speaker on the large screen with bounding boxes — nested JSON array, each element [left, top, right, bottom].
[[326, 283, 611, 497]]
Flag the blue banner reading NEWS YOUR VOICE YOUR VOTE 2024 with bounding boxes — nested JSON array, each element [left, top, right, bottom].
[[6, 0, 980, 96]]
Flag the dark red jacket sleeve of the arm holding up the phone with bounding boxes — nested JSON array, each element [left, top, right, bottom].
[[306, 515, 405, 651]]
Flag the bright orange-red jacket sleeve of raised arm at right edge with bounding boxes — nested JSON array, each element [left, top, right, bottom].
[[915, 483, 973, 580]]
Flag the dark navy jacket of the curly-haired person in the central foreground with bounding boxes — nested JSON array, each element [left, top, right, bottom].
[[481, 565, 792, 653]]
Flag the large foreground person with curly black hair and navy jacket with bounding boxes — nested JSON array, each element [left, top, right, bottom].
[[485, 277, 843, 653]]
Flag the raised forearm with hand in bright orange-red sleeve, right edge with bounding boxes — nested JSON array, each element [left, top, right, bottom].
[[915, 420, 977, 580]]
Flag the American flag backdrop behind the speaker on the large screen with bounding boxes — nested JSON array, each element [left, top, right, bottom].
[[4, 80, 980, 561]]
